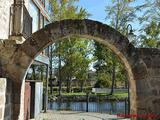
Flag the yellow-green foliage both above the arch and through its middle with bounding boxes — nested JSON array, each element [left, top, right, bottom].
[[50, 0, 91, 92]]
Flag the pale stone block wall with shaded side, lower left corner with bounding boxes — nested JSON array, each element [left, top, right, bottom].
[[0, 78, 12, 120]]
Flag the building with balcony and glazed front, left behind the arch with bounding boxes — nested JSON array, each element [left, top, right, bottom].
[[0, 0, 51, 119]]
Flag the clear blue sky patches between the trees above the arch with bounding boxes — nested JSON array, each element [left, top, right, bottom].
[[78, 0, 145, 35]]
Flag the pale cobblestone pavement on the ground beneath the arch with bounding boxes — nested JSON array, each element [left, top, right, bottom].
[[35, 111, 130, 120]]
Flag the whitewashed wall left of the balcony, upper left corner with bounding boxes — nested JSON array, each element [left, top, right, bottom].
[[0, 0, 13, 39]]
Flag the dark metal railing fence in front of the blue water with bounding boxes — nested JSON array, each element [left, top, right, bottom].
[[48, 95, 128, 114]]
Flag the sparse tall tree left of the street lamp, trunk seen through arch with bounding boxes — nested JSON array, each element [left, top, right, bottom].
[[102, 0, 139, 94]]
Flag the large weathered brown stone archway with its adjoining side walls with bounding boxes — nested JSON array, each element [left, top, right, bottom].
[[0, 19, 160, 120]]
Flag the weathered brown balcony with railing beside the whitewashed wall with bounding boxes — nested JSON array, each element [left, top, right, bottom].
[[10, 4, 32, 42]]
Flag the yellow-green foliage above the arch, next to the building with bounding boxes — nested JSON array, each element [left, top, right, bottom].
[[50, 0, 90, 21]]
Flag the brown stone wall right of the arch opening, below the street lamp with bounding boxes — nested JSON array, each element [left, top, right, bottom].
[[134, 48, 160, 120]]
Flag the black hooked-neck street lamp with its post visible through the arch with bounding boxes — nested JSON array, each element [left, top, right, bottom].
[[126, 24, 135, 115]]
